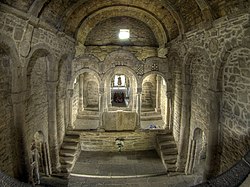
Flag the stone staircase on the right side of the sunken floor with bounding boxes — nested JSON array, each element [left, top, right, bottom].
[[156, 132, 178, 172]]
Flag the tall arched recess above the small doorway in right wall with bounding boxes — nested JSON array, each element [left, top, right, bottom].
[[177, 48, 216, 172]]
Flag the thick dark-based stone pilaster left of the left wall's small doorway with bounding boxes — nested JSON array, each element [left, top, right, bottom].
[[11, 92, 30, 182]]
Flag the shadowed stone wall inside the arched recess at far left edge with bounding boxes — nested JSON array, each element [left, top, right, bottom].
[[0, 49, 15, 176]]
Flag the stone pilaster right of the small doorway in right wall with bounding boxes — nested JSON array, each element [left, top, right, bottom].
[[204, 90, 221, 179]]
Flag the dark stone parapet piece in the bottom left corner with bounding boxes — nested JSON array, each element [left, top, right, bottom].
[[0, 171, 31, 187]]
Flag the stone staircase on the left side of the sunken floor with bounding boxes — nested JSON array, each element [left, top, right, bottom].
[[59, 131, 81, 177]]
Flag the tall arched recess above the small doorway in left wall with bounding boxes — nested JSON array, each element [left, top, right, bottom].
[[25, 44, 59, 172]]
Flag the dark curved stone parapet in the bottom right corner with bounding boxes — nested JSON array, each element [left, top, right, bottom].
[[194, 151, 250, 187]]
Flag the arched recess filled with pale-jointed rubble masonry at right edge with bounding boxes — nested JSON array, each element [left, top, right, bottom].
[[218, 47, 250, 172]]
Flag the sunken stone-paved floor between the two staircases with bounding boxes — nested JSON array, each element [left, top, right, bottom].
[[72, 150, 166, 178]]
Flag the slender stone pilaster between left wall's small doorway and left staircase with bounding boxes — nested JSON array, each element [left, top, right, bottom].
[[47, 81, 60, 173]]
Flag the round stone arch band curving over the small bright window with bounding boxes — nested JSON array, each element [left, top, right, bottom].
[[76, 6, 169, 47]]
